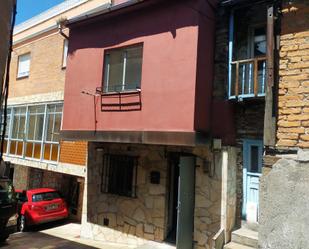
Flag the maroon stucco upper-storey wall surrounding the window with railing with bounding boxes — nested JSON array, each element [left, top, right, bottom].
[[62, 1, 214, 136]]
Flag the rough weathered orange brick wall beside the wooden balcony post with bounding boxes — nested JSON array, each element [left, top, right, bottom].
[[277, 1, 309, 148]]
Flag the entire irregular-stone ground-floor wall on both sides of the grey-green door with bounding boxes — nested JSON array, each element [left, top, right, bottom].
[[81, 143, 226, 249]]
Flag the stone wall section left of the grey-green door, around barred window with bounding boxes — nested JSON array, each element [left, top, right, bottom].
[[82, 143, 167, 245]]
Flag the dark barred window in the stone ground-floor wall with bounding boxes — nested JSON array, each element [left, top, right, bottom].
[[101, 154, 137, 197]]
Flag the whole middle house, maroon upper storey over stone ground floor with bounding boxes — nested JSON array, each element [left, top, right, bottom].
[[61, 0, 237, 249]]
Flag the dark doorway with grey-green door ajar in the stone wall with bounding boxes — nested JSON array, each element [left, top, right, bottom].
[[166, 154, 195, 249]]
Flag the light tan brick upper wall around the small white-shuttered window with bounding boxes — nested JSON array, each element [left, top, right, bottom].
[[9, 30, 65, 98]]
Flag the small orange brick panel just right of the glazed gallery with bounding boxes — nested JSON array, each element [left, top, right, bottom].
[[59, 141, 88, 165]]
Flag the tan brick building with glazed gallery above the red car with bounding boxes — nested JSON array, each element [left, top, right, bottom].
[[3, 0, 109, 220]]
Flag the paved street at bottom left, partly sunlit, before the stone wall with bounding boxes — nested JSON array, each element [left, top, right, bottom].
[[0, 222, 174, 249]]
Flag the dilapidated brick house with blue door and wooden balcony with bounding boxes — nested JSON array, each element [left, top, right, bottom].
[[213, 1, 308, 248]]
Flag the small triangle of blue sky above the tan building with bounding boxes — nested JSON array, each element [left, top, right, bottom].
[[16, 0, 64, 25]]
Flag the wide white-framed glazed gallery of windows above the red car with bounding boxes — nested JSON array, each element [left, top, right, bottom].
[[4, 103, 63, 162]]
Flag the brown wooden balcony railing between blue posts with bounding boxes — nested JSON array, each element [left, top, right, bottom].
[[229, 57, 266, 99]]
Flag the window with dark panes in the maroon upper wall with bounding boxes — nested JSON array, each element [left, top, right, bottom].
[[104, 44, 143, 92]]
